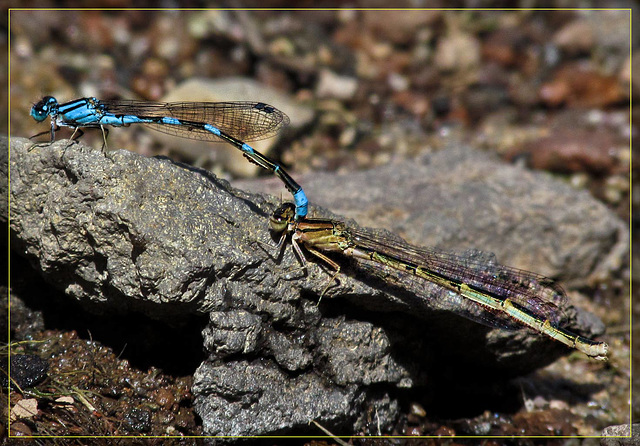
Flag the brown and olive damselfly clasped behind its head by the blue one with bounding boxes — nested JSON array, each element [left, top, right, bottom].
[[270, 203, 608, 360]]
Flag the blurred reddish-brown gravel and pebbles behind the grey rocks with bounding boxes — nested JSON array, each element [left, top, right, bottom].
[[7, 6, 638, 207]]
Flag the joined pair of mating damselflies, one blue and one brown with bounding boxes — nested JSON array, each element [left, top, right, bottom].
[[31, 96, 608, 359]]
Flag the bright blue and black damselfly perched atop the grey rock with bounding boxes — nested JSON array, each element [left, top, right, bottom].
[[31, 96, 308, 219]]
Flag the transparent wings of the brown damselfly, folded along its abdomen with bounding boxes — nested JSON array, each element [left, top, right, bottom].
[[349, 229, 567, 328]]
